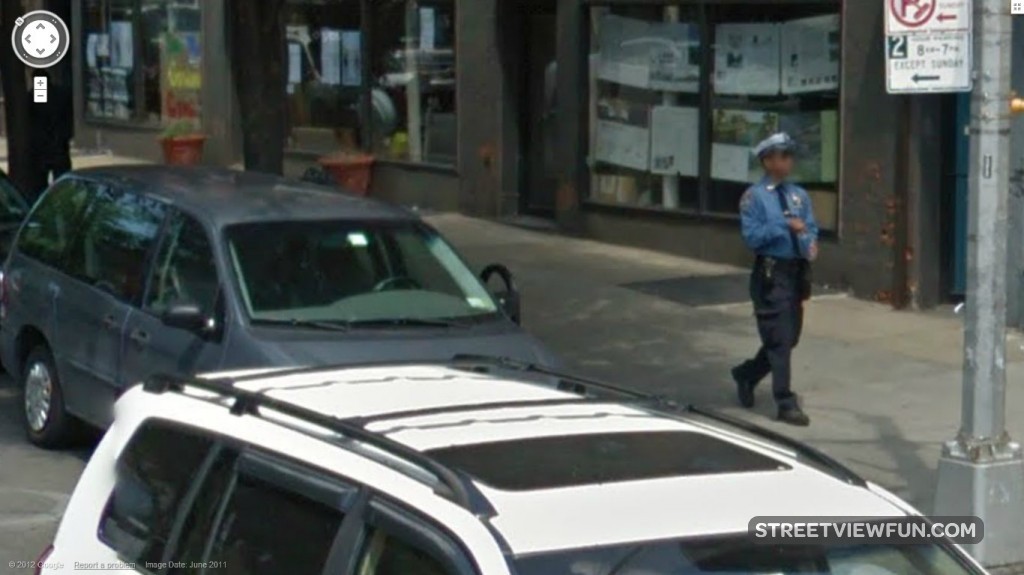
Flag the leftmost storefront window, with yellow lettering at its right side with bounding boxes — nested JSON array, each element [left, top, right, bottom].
[[81, 0, 202, 125]]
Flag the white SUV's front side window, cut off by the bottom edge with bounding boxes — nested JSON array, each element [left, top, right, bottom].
[[356, 501, 475, 575]]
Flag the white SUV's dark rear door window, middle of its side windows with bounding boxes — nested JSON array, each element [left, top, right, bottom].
[[201, 454, 355, 575]]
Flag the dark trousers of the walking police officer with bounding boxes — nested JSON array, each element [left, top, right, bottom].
[[737, 256, 807, 407]]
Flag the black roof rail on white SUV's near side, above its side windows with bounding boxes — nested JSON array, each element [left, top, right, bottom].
[[142, 375, 496, 517]]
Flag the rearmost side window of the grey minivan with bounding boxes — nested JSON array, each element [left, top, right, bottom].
[[17, 178, 88, 266]]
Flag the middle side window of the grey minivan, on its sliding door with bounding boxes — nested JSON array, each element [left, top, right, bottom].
[[69, 182, 166, 302]]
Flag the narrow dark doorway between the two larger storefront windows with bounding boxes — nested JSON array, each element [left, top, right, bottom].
[[519, 2, 558, 217]]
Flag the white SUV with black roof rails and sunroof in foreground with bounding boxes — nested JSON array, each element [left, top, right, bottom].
[[41, 358, 983, 575]]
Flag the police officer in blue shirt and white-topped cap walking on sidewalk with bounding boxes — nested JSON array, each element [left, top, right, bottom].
[[732, 133, 818, 426]]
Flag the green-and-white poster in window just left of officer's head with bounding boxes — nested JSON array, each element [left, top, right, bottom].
[[712, 108, 774, 182]]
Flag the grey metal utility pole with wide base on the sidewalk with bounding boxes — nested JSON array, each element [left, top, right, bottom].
[[935, 0, 1024, 567]]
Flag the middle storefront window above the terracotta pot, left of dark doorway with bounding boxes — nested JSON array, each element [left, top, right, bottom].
[[288, 0, 456, 164]]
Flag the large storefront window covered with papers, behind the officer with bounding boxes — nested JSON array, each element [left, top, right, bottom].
[[588, 2, 841, 229]]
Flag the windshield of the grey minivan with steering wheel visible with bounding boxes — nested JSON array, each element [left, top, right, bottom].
[[226, 221, 498, 324]]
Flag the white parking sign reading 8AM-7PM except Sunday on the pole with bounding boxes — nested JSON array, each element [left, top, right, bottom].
[[885, 0, 973, 94]]
